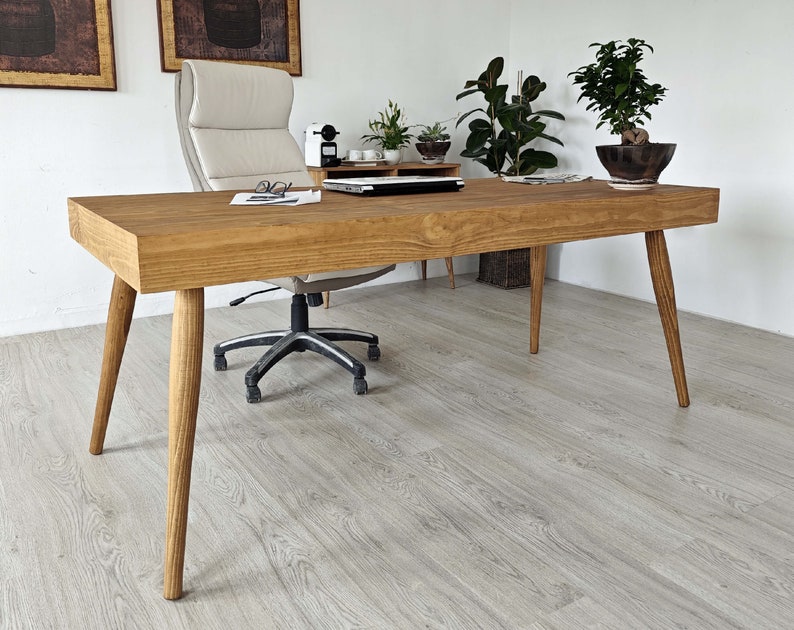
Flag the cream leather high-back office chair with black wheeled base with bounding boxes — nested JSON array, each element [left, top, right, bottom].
[[176, 60, 394, 403]]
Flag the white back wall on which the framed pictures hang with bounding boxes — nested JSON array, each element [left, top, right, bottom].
[[0, 0, 508, 336]]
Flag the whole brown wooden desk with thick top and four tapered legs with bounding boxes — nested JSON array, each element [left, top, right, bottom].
[[68, 178, 719, 599]]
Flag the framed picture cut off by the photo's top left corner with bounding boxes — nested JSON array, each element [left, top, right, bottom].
[[0, 0, 116, 90]]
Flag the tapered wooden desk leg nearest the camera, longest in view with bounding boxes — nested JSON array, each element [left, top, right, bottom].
[[163, 289, 204, 599]]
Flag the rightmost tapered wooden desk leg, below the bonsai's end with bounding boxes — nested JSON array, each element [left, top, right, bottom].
[[645, 230, 689, 407]]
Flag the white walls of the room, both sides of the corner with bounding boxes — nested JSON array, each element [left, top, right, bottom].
[[0, 0, 794, 336]]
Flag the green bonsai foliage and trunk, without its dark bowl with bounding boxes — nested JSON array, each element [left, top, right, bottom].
[[568, 37, 667, 145]]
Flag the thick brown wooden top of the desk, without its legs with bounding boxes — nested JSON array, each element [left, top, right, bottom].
[[68, 178, 719, 293]]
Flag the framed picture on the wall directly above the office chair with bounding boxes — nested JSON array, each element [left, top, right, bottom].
[[157, 0, 301, 76]]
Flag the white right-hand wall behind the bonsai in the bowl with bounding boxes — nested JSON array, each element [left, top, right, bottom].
[[510, 0, 794, 335]]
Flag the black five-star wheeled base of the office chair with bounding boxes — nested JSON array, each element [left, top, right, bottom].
[[213, 294, 380, 403]]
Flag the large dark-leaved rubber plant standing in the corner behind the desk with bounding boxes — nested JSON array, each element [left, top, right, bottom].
[[456, 57, 565, 175]]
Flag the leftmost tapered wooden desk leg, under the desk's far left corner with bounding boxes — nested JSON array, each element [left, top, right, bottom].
[[88, 276, 138, 455]]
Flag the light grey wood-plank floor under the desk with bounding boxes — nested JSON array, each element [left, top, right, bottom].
[[0, 276, 794, 630]]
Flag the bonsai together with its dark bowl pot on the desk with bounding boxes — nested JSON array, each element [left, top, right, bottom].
[[568, 37, 676, 189]]
